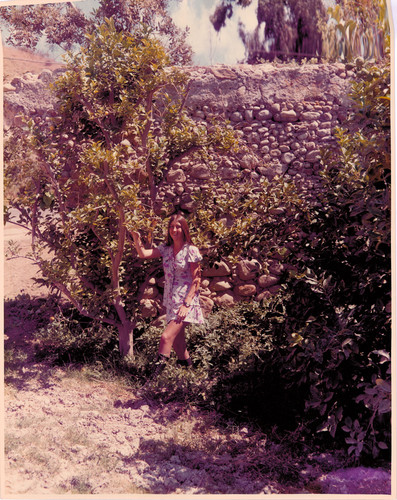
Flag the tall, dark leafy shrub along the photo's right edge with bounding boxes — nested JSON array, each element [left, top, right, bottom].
[[266, 56, 391, 457]]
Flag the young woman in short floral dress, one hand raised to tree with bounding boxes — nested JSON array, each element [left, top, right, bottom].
[[131, 214, 204, 372]]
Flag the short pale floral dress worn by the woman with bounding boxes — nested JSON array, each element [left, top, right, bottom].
[[157, 243, 204, 324]]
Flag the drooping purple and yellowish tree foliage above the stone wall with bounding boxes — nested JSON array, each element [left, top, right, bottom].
[[210, 0, 390, 64]]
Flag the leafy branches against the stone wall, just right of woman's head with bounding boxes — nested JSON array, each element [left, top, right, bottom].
[[190, 173, 311, 273]]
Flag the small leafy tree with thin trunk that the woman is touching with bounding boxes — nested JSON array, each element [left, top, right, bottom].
[[6, 20, 235, 355]]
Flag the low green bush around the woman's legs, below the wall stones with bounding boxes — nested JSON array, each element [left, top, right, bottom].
[[131, 297, 304, 429]]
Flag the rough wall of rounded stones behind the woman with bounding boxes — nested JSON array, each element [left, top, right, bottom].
[[4, 64, 353, 317]]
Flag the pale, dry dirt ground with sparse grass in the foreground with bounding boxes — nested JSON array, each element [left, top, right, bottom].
[[6, 365, 279, 498]]
